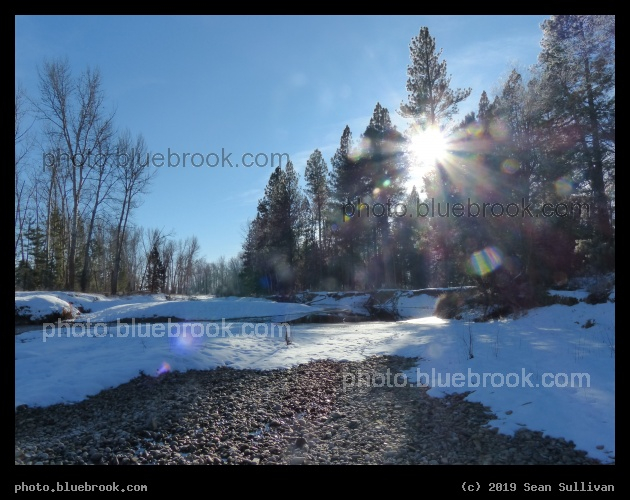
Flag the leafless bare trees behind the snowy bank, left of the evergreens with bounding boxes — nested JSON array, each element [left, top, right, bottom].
[[15, 59, 240, 295]]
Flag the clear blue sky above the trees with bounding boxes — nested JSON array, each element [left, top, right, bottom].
[[15, 15, 549, 261]]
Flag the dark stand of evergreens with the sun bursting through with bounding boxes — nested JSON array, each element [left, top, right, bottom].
[[241, 15, 615, 298]]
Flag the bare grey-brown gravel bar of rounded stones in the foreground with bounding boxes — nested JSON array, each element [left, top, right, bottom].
[[15, 356, 600, 465]]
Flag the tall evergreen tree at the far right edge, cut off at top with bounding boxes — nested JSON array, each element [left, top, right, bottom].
[[539, 15, 615, 269]]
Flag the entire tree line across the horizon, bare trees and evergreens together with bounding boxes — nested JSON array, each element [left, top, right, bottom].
[[15, 15, 615, 296]]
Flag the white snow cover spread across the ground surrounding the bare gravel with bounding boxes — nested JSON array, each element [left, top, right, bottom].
[[15, 290, 615, 463]]
